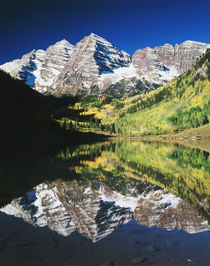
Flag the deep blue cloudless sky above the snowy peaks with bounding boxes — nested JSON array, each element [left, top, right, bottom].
[[0, 0, 210, 64]]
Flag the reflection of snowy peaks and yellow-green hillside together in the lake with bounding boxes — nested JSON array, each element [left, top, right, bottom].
[[1, 141, 210, 242]]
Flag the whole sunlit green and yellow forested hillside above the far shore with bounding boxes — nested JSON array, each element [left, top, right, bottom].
[[71, 49, 210, 136]]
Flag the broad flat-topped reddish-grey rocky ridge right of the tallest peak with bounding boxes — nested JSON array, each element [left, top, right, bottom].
[[132, 41, 210, 84]]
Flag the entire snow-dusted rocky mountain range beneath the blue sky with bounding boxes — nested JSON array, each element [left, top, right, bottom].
[[0, 33, 210, 96]]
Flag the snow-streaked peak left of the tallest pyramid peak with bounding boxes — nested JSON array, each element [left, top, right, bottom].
[[0, 40, 74, 93]]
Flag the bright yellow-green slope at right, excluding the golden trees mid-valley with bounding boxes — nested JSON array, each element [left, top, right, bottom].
[[113, 49, 210, 135]]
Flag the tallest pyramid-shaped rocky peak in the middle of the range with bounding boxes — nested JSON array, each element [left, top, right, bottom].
[[53, 33, 130, 94]]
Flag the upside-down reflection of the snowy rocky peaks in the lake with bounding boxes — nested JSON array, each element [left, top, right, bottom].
[[0, 181, 210, 242]]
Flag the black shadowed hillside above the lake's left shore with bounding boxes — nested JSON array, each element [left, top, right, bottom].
[[0, 71, 107, 144]]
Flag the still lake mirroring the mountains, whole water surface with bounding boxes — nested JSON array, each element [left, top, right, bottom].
[[0, 140, 210, 266]]
